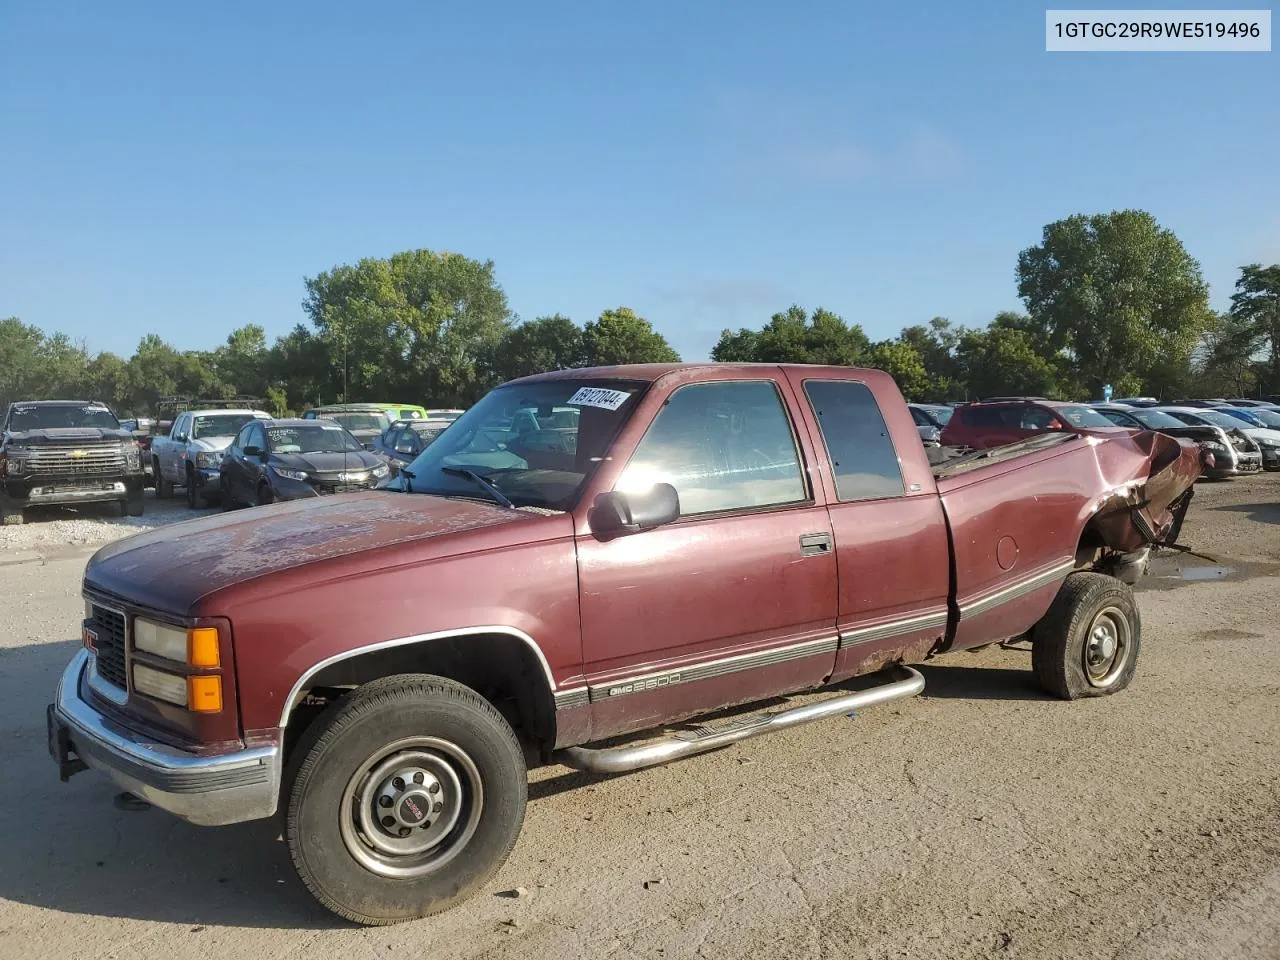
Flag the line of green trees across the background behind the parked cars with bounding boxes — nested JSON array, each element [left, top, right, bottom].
[[0, 210, 1280, 416]]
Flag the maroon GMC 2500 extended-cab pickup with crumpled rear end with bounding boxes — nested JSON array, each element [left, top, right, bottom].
[[49, 364, 1199, 924]]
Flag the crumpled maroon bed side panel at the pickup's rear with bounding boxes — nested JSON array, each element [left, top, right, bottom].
[[937, 433, 1201, 649]]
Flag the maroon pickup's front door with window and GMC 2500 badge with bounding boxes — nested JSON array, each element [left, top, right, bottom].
[[577, 375, 837, 736]]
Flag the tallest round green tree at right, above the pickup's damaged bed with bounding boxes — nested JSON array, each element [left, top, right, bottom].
[[1018, 210, 1210, 396]]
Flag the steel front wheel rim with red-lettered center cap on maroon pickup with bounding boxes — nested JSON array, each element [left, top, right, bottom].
[[338, 737, 484, 879]]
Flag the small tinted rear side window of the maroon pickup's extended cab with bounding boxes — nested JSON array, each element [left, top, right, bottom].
[[804, 380, 905, 500]]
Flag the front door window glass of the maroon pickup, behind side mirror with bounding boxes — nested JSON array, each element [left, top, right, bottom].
[[617, 380, 808, 516]]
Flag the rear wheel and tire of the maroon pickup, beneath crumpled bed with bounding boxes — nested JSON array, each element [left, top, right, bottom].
[[1032, 573, 1142, 700]]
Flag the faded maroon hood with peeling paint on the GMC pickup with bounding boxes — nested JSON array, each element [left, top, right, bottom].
[[84, 492, 539, 613]]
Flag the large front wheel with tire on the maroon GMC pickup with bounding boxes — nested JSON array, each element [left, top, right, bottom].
[[285, 675, 527, 925]]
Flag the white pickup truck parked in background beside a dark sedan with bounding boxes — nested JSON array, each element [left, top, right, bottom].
[[151, 408, 271, 509]]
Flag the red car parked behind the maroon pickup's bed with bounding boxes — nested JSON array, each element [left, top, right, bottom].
[[940, 398, 1128, 451]]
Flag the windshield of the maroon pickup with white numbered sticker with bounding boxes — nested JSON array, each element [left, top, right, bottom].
[[392, 379, 648, 509]]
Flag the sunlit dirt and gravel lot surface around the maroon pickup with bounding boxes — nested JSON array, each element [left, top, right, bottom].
[[0, 475, 1280, 960]]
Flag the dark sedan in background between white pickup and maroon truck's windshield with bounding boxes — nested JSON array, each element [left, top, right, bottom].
[[219, 420, 390, 509]]
